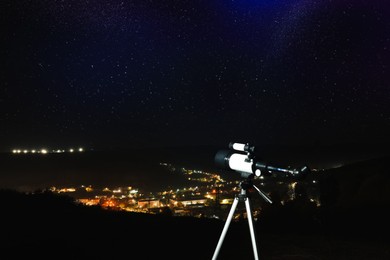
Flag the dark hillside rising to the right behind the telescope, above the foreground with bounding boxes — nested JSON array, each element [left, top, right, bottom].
[[250, 157, 390, 242]]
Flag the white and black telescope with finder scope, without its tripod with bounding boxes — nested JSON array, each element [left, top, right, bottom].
[[214, 142, 310, 179]]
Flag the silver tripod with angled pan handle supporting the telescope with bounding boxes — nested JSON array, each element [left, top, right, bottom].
[[212, 178, 272, 260]]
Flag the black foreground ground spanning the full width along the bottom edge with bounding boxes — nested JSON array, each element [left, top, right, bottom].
[[0, 185, 390, 260]]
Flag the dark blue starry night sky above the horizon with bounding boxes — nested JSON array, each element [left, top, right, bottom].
[[0, 0, 390, 151]]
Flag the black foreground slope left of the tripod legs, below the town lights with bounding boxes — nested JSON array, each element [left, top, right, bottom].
[[0, 191, 227, 259]]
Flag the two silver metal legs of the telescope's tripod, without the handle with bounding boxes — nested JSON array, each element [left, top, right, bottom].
[[212, 190, 259, 260]]
